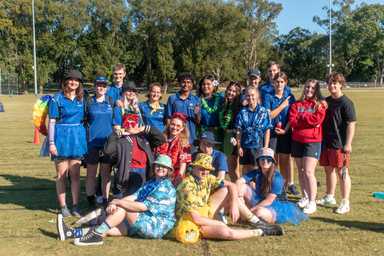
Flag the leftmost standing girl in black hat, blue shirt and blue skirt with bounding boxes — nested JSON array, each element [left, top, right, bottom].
[[48, 70, 87, 217]]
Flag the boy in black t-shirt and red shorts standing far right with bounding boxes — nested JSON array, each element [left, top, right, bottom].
[[317, 73, 356, 214]]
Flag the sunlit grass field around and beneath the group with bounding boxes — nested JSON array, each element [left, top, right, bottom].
[[0, 90, 384, 256]]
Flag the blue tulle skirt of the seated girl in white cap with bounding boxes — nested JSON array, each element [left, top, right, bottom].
[[266, 199, 308, 225]]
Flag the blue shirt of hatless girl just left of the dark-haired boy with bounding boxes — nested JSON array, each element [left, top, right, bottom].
[[139, 101, 165, 132]]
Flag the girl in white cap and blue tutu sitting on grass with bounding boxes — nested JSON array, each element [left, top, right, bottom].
[[236, 148, 307, 224]]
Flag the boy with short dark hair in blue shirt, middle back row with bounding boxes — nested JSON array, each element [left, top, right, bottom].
[[165, 73, 201, 144]]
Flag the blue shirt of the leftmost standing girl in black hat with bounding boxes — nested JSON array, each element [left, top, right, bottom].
[[49, 92, 84, 124]]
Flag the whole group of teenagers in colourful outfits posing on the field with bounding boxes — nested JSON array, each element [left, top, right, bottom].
[[48, 62, 356, 245]]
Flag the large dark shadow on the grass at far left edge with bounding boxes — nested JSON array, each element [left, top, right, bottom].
[[0, 174, 57, 212]]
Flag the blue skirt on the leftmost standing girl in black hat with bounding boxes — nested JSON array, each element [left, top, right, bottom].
[[55, 124, 87, 159]]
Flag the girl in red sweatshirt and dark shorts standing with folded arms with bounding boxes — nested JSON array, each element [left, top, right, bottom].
[[289, 80, 327, 214]]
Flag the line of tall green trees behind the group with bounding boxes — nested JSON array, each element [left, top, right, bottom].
[[0, 0, 384, 91]]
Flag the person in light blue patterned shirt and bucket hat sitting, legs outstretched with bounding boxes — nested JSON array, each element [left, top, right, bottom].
[[57, 155, 176, 246]]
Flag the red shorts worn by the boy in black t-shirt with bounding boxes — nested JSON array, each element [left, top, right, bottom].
[[320, 147, 351, 169]]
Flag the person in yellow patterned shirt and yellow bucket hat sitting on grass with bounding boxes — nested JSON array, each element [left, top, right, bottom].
[[174, 153, 283, 240]]
